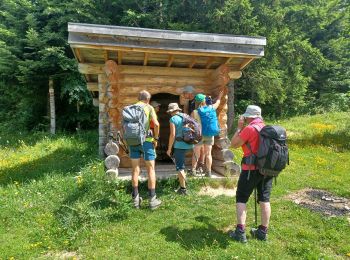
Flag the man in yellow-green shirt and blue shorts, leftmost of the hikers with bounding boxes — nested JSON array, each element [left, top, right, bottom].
[[129, 90, 162, 209]]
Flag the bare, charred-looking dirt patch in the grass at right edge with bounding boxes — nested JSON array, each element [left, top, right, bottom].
[[287, 189, 350, 217]]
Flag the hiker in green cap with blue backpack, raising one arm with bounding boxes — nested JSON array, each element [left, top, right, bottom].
[[192, 91, 223, 177]]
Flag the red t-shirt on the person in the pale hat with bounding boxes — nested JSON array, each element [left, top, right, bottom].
[[239, 118, 265, 170]]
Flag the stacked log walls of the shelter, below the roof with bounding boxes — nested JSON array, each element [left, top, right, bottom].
[[95, 60, 240, 174]]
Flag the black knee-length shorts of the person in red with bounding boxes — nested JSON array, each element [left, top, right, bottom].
[[236, 170, 273, 203]]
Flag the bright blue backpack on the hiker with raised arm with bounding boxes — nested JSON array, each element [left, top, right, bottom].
[[198, 106, 220, 136]]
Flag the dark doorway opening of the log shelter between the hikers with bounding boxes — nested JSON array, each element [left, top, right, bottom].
[[151, 93, 180, 163]]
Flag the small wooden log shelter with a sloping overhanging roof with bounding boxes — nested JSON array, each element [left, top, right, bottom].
[[68, 23, 266, 174]]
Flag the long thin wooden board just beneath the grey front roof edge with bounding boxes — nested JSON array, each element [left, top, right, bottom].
[[71, 44, 261, 58]]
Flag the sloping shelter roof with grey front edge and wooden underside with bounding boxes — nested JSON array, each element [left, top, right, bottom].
[[68, 23, 266, 85]]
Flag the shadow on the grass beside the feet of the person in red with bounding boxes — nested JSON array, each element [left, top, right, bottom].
[[160, 216, 229, 250]]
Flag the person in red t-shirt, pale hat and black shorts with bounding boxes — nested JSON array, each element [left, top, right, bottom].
[[229, 105, 273, 243]]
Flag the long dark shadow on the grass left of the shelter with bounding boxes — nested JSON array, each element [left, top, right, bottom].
[[0, 148, 96, 186]]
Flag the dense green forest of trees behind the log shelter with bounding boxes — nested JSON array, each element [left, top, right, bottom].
[[0, 0, 350, 131]]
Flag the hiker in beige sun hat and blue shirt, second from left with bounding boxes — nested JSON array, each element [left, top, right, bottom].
[[167, 103, 193, 195]]
